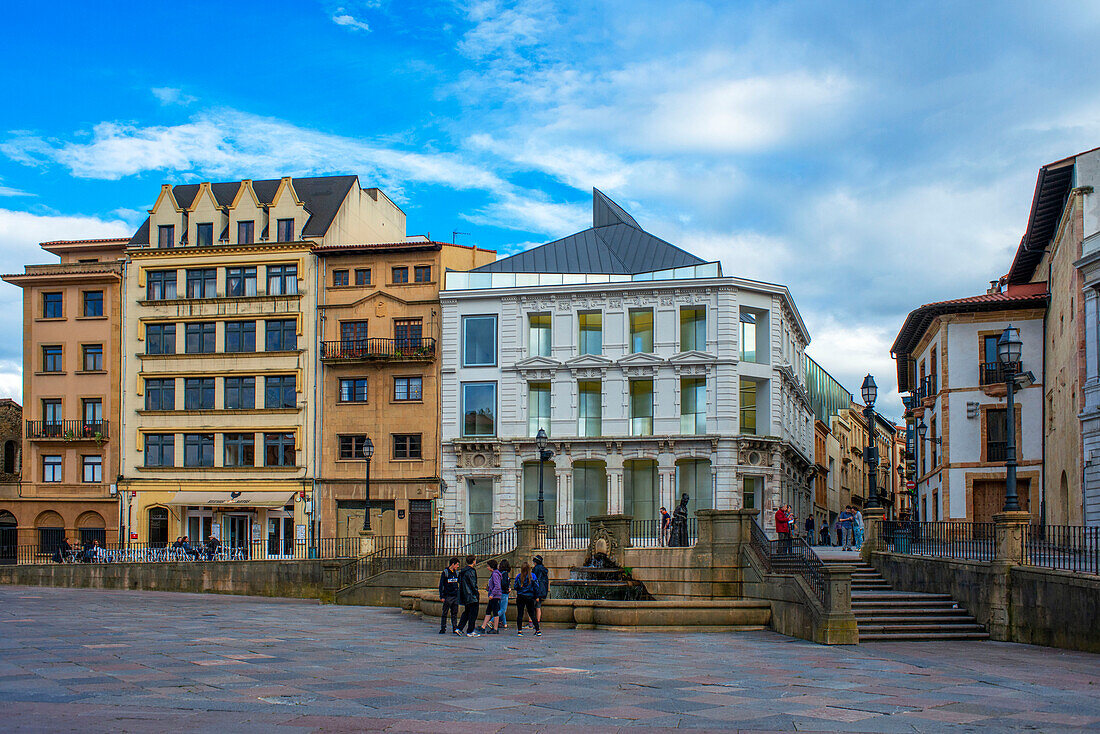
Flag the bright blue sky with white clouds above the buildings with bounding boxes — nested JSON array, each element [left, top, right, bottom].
[[0, 0, 1100, 413]]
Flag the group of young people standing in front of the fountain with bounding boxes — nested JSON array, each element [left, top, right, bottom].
[[439, 556, 550, 637]]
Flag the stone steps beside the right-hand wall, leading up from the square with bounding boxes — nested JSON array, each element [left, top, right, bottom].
[[825, 560, 989, 643]]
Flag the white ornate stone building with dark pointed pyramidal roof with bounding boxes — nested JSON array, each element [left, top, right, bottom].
[[440, 190, 813, 533]]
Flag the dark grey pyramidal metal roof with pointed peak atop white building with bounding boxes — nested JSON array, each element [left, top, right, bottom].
[[473, 188, 706, 275]]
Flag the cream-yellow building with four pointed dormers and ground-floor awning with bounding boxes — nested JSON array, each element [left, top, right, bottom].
[[119, 176, 405, 557]]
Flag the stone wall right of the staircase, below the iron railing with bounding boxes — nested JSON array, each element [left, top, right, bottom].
[[871, 552, 1100, 653]]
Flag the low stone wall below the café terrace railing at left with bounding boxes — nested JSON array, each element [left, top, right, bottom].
[[0, 560, 321, 599]]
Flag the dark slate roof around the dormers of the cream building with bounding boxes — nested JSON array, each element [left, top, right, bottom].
[[130, 176, 359, 247]]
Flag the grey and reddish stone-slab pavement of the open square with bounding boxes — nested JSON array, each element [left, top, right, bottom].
[[0, 587, 1100, 734]]
